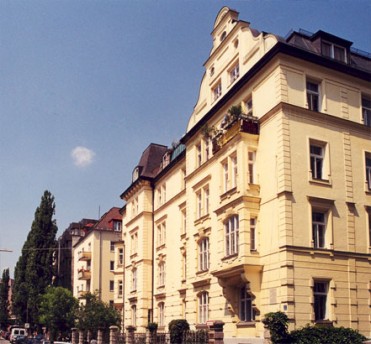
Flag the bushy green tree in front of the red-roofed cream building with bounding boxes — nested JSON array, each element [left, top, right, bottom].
[[77, 293, 121, 337]]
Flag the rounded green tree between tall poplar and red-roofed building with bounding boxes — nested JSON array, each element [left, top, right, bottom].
[[39, 287, 78, 341]]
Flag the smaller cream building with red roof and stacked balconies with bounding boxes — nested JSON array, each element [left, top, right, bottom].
[[73, 207, 122, 306]]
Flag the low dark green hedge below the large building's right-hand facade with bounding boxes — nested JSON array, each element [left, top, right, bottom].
[[290, 326, 366, 344]]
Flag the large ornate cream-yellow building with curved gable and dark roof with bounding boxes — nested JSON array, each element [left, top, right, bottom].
[[121, 7, 371, 343]]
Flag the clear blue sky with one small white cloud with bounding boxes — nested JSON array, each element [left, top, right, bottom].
[[0, 0, 371, 272]]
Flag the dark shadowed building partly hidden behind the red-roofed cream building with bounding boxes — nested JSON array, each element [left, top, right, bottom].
[[56, 219, 97, 291]]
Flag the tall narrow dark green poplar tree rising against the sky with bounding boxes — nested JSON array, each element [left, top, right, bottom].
[[13, 191, 58, 324]]
